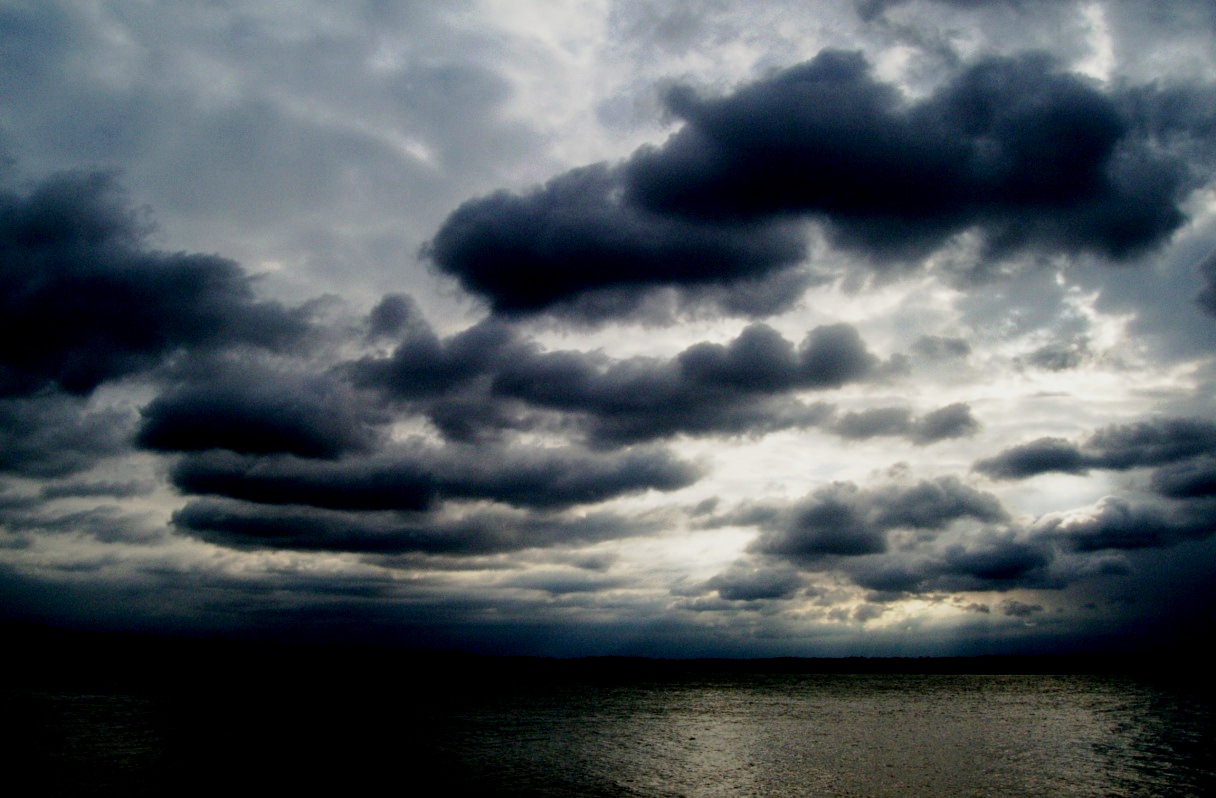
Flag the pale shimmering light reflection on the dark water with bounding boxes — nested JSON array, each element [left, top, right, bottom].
[[425, 675, 1216, 797]]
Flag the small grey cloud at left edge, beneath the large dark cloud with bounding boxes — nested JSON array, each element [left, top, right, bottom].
[[0, 396, 133, 477]]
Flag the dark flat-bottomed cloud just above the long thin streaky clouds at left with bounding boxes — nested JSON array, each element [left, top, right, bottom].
[[136, 364, 388, 459]]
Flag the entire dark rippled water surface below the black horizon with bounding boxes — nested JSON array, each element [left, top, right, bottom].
[[0, 674, 1216, 798]]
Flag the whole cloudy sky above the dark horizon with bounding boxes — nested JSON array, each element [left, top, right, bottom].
[[0, 0, 1216, 657]]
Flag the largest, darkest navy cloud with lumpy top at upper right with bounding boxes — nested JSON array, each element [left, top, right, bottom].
[[627, 51, 1187, 258]]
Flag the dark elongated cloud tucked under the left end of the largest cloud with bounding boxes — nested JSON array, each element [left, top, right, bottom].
[[426, 164, 804, 313]]
